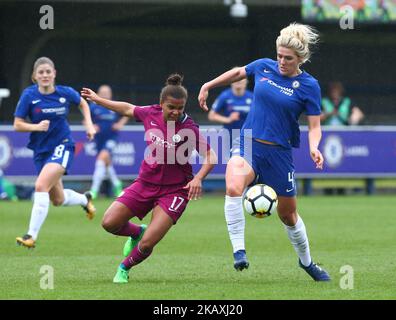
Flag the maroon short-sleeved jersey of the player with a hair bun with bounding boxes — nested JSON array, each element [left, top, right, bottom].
[[134, 104, 210, 185]]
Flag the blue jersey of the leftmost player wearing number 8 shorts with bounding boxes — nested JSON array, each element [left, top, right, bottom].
[[14, 85, 81, 155]]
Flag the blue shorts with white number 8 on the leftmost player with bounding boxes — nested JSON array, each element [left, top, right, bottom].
[[33, 144, 74, 174]]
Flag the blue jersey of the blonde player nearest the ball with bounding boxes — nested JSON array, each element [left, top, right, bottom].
[[243, 59, 321, 148]]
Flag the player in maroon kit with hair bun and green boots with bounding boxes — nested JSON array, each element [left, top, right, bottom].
[[82, 74, 216, 283]]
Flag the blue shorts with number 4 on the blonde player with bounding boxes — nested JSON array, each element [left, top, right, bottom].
[[232, 139, 297, 197]]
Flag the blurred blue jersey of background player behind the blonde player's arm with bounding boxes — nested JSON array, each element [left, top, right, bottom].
[[212, 88, 253, 130]]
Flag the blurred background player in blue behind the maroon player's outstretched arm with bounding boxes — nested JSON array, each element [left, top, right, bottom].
[[89, 85, 128, 199]]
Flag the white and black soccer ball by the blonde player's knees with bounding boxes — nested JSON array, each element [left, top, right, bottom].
[[243, 184, 278, 218]]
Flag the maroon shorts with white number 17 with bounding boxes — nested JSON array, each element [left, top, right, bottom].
[[116, 179, 189, 224]]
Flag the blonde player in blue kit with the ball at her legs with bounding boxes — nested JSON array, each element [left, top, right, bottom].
[[198, 23, 330, 281]]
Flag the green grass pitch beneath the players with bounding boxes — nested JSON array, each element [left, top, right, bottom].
[[0, 195, 396, 300]]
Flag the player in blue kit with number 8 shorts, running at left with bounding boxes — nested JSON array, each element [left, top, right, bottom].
[[14, 57, 95, 248]]
